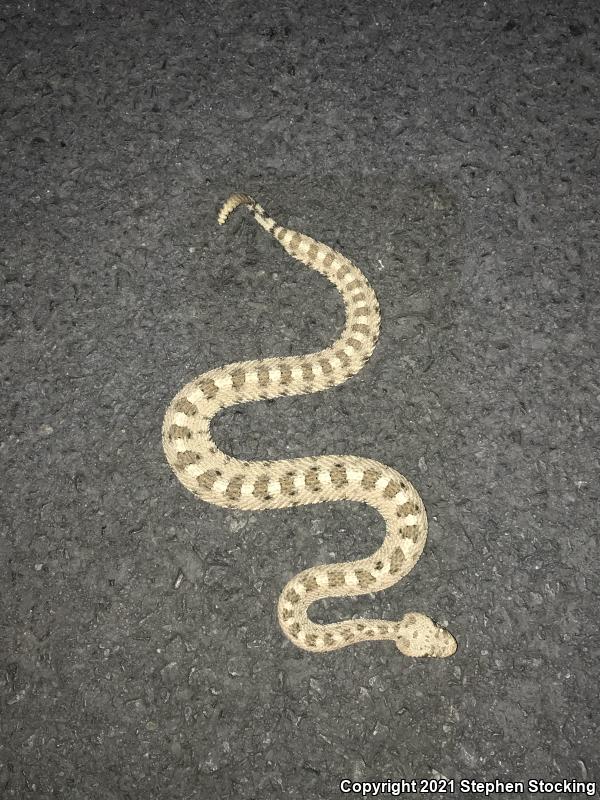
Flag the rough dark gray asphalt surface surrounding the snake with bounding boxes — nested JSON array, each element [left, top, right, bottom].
[[0, 0, 600, 800]]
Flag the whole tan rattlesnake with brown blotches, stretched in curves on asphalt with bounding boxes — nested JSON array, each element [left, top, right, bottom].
[[163, 194, 456, 657]]
